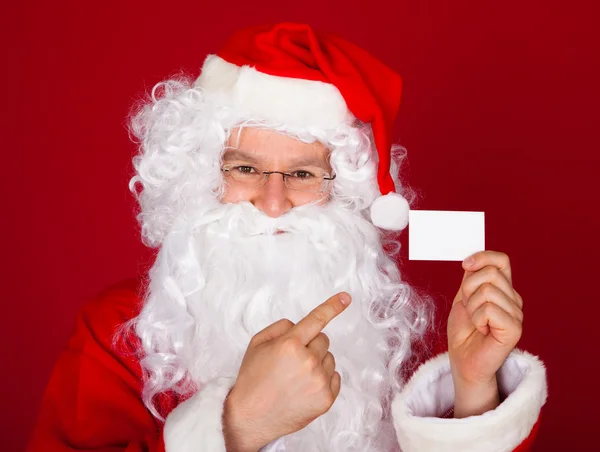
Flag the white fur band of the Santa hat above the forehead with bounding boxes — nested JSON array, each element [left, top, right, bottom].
[[194, 55, 354, 130]]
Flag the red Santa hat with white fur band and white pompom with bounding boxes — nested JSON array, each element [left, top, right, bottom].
[[195, 23, 409, 230]]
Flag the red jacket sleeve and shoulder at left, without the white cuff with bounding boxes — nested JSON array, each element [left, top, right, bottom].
[[27, 281, 164, 452]]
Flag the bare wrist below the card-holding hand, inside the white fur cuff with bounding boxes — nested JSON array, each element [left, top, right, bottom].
[[453, 375, 500, 418]]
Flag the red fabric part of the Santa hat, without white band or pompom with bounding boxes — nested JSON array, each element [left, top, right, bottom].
[[218, 23, 402, 195]]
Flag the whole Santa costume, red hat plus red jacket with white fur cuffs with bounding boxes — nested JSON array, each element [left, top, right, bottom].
[[29, 24, 547, 452]]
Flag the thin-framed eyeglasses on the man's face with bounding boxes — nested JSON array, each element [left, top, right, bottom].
[[221, 165, 335, 193]]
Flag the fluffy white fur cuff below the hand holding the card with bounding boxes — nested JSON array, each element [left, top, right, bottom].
[[392, 350, 547, 452]]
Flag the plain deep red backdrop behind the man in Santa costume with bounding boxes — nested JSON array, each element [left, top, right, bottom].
[[0, 0, 600, 451]]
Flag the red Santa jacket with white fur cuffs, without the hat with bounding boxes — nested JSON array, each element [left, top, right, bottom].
[[27, 280, 546, 452]]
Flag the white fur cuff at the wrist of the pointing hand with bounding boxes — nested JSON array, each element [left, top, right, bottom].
[[163, 378, 234, 452]]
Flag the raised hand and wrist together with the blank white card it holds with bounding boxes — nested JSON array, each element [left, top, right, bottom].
[[409, 211, 523, 418]]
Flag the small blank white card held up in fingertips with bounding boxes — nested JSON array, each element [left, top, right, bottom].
[[408, 210, 485, 261]]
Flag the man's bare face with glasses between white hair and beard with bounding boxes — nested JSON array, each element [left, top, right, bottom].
[[221, 127, 332, 218]]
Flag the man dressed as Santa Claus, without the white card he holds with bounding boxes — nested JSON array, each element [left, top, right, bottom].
[[29, 23, 546, 452]]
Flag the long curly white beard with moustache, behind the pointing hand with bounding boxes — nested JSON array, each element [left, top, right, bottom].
[[136, 203, 418, 451]]
